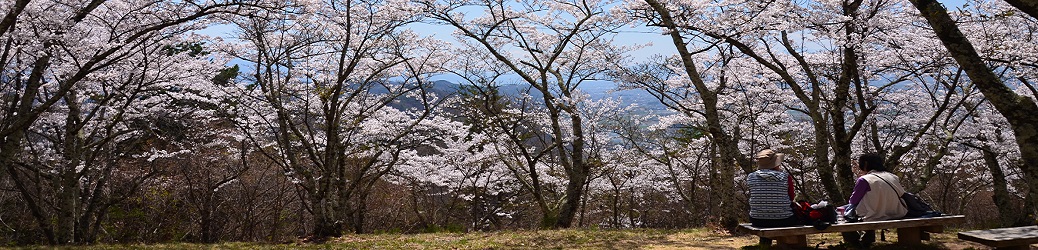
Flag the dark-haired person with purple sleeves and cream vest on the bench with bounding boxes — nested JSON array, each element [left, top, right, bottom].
[[843, 154, 908, 247]]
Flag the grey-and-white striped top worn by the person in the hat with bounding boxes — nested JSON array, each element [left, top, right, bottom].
[[746, 169, 793, 220]]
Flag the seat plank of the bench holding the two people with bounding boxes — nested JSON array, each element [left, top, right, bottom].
[[739, 216, 966, 238]]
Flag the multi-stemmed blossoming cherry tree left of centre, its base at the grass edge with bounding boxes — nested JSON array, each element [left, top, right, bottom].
[[229, 1, 447, 239]]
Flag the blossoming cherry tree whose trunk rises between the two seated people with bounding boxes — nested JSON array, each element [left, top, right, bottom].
[[614, 1, 971, 205]]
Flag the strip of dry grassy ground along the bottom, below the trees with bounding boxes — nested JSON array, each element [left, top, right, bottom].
[[8, 228, 986, 249]]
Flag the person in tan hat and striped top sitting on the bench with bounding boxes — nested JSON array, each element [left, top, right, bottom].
[[746, 149, 799, 245]]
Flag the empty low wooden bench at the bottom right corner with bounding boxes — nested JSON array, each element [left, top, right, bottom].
[[959, 226, 1038, 249]]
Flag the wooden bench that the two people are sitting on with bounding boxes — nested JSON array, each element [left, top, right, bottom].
[[739, 216, 966, 247]]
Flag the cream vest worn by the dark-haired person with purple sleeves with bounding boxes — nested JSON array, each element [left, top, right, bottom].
[[854, 171, 908, 221]]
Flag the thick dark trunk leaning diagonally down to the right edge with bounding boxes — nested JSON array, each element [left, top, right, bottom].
[[911, 0, 1038, 224]]
